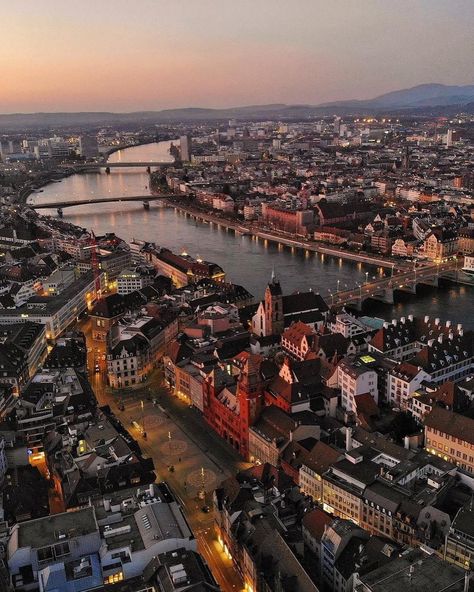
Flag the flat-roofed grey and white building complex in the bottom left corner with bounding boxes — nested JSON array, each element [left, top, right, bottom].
[[6, 484, 197, 592]]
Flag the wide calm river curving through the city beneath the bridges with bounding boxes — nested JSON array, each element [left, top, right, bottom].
[[31, 142, 474, 328]]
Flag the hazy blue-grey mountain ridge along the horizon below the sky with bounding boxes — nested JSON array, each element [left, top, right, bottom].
[[0, 84, 474, 132]]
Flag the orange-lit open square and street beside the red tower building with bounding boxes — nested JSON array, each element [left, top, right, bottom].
[[81, 322, 244, 592]]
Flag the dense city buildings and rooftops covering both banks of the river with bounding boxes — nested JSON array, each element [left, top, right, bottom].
[[0, 117, 474, 592]]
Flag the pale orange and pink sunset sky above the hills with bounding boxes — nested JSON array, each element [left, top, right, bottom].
[[0, 0, 474, 113]]
